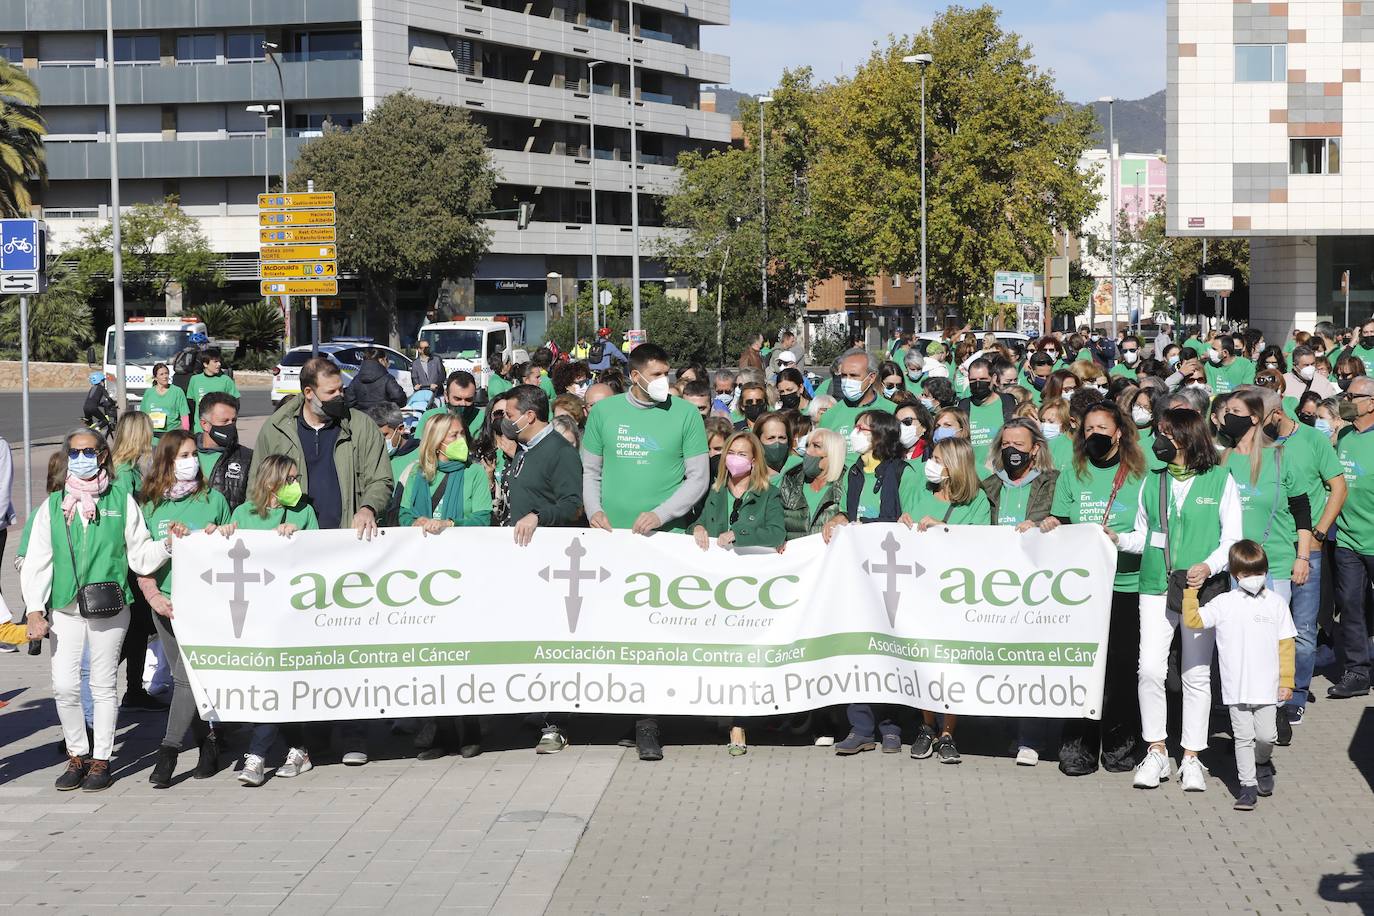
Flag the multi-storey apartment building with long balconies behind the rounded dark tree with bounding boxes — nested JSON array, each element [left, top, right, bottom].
[[0, 0, 730, 339]]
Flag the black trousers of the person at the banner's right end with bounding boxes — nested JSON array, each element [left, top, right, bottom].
[[1059, 592, 1140, 776]]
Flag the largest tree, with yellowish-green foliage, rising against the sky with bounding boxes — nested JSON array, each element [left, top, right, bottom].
[[811, 5, 1096, 306]]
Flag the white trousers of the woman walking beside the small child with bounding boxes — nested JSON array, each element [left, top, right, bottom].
[[1138, 595, 1216, 751]]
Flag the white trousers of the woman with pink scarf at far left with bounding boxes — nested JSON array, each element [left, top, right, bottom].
[[51, 606, 129, 761]]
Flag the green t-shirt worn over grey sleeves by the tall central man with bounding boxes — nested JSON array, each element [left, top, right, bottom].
[[583, 394, 708, 531]]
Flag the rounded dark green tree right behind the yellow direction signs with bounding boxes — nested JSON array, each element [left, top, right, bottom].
[[291, 92, 497, 346]]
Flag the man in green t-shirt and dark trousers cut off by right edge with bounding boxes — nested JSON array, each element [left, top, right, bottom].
[[1326, 376, 1374, 699]]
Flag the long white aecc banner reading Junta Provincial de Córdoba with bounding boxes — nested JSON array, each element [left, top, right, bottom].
[[172, 525, 1116, 722]]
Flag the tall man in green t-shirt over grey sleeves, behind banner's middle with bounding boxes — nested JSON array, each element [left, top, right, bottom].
[[583, 343, 709, 761]]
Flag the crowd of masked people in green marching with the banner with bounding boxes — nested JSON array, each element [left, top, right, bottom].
[[5, 315, 1374, 808]]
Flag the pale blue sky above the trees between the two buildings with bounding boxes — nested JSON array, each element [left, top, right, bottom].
[[701, 0, 1164, 102]]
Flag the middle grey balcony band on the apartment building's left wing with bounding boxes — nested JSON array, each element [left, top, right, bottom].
[[29, 59, 363, 106]]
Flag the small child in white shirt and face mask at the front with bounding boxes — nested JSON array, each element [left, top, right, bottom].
[[1183, 540, 1297, 812]]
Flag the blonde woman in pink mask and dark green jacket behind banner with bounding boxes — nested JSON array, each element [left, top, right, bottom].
[[692, 431, 787, 757]]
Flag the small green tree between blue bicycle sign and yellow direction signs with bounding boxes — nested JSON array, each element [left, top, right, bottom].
[[63, 196, 224, 308]]
